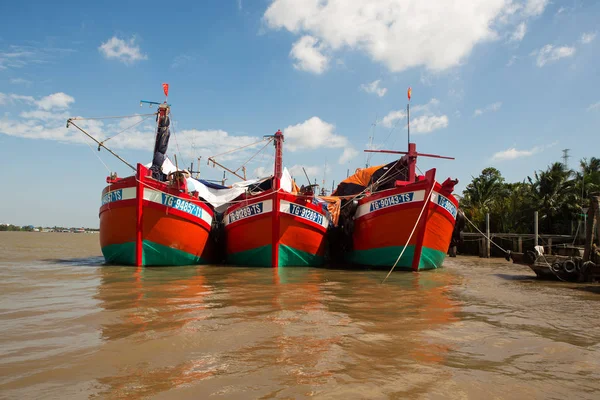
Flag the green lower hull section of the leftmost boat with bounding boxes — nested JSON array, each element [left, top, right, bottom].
[[102, 240, 204, 266]]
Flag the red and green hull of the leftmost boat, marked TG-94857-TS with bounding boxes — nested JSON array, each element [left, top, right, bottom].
[[100, 165, 213, 266]]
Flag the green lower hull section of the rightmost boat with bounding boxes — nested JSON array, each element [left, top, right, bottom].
[[348, 246, 446, 270]]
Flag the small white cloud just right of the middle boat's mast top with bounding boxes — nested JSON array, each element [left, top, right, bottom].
[[283, 117, 348, 151]]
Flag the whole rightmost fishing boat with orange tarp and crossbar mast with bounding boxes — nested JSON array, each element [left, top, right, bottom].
[[332, 90, 461, 271]]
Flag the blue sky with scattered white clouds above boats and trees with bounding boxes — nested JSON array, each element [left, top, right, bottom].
[[0, 0, 600, 227]]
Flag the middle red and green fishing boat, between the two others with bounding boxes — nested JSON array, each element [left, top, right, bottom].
[[223, 131, 330, 267]]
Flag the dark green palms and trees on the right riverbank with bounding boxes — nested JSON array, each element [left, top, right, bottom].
[[460, 157, 600, 235]]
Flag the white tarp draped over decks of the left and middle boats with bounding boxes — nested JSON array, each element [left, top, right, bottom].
[[146, 157, 292, 212]]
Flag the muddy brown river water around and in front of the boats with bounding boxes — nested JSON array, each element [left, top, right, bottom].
[[0, 232, 600, 400]]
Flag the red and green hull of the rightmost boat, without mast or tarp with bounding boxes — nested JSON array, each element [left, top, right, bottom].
[[347, 170, 458, 271]]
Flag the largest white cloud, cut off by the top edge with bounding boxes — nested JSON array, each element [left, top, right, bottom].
[[264, 0, 548, 72]]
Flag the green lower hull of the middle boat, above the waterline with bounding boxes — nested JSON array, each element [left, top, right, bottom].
[[227, 244, 325, 267]]
